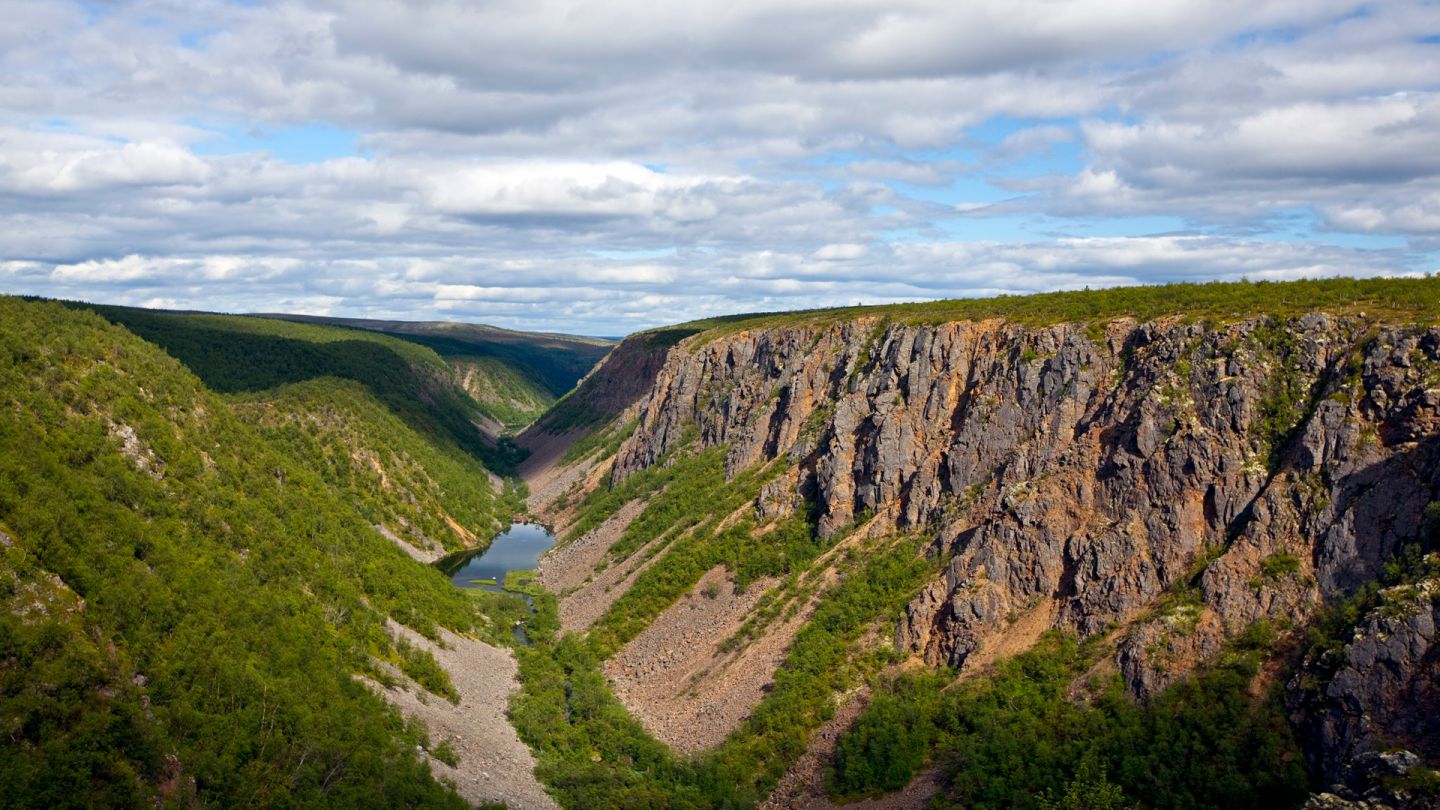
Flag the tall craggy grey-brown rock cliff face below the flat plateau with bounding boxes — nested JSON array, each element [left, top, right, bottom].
[[612, 314, 1440, 693]]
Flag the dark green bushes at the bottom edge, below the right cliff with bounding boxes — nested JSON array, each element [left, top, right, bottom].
[[831, 633, 1309, 809]]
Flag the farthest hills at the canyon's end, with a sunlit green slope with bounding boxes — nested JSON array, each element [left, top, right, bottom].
[[266, 316, 615, 431]]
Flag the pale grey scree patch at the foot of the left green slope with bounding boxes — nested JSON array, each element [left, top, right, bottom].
[[361, 620, 559, 810]]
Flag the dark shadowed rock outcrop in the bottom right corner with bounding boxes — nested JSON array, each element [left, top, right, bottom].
[[1289, 570, 1440, 784]]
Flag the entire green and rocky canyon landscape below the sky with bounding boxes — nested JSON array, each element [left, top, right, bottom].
[[0, 278, 1440, 809]]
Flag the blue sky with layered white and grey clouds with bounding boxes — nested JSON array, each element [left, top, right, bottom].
[[0, 0, 1440, 336]]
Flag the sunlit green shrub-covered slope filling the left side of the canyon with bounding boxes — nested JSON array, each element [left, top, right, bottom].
[[0, 298, 498, 807]]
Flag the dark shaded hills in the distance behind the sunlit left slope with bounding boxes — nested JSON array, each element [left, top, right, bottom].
[[59, 303, 611, 474]]
